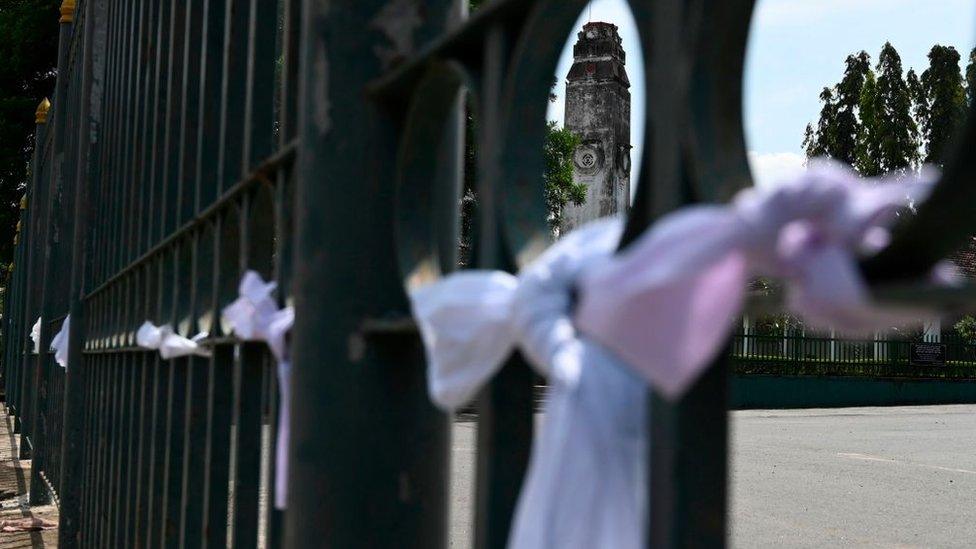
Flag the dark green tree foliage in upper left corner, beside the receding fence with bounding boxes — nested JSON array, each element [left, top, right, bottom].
[[0, 0, 61, 265]]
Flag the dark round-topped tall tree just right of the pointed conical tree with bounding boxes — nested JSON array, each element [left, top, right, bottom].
[[914, 45, 966, 165]]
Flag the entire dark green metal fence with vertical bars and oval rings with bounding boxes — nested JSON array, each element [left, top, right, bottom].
[[3, 0, 976, 548]]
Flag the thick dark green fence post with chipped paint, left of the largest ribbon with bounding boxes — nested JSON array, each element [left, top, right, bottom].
[[285, 0, 454, 547]]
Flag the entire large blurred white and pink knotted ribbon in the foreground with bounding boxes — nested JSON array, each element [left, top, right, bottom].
[[411, 164, 944, 549]]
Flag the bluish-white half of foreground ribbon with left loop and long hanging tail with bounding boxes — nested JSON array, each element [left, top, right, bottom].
[[411, 220, 647, 549]]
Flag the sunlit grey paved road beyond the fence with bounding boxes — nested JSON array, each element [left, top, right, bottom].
[[451, 406, 976, 548]]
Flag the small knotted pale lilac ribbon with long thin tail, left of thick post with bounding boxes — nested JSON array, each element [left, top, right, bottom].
[[222, 271, 295, 509]]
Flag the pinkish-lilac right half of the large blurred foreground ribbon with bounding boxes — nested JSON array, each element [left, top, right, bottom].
[[574, 162, 932, 398]]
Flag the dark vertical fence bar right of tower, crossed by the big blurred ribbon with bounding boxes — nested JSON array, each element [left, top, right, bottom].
[[624, 0, 728, 548]]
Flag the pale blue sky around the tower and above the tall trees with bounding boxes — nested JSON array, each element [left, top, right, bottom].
[[549, 0, 976, 185]]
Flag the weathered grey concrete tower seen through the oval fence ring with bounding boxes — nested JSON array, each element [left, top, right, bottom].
[[561, 23, 630, 234]]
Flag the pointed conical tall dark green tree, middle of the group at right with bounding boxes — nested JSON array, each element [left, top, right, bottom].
[[864, 42, 920, 172]]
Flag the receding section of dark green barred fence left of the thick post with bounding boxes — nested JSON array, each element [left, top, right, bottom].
[[4, 0, 300, 547]]
